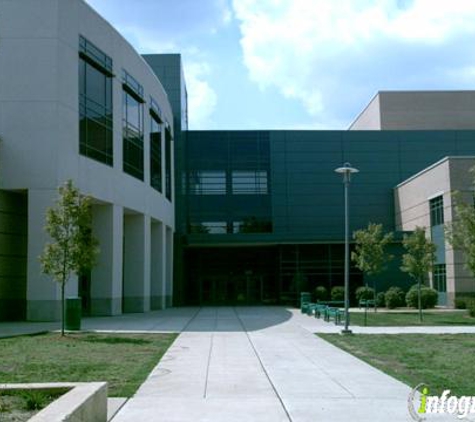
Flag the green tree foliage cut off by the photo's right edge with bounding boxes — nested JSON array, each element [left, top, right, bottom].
[[445, 177, 475, 277]]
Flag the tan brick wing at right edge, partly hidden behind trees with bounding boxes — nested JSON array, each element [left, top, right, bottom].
[[394, 156, 475, 304]]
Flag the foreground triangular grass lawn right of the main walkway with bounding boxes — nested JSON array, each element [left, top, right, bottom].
[[319, 334, 475, 396]]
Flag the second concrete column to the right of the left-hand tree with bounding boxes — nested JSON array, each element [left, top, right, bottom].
[[123, 214, 150, 312]]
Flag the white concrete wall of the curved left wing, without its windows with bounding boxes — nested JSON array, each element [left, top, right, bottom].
[[0, 0, 175, 320]]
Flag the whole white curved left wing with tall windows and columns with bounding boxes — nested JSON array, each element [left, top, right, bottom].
[[0, 0, 175, 320]]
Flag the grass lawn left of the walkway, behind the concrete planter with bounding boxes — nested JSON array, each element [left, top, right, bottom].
[[0, 333, 177, 397]]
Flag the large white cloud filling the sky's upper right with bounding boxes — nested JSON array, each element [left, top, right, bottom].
[[233, 0, 475, 127]]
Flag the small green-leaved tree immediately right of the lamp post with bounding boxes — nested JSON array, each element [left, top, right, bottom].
[[351, 223, 394, 302]]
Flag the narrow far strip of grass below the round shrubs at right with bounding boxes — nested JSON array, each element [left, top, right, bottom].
[[350, 309, 475, 327]]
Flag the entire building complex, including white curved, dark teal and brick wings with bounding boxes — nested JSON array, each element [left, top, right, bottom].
[[0, 0, 475, 320]]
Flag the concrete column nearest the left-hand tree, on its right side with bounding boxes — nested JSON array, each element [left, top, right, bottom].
[[91, 205, 124, 315]]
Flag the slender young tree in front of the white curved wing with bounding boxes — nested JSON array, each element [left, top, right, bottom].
[[40, 180, 99, 336]]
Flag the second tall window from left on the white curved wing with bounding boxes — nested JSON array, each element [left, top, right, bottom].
[[122, 71, 144, 180]]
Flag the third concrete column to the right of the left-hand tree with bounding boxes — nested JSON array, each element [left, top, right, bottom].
[[150, 221, 166, 310]]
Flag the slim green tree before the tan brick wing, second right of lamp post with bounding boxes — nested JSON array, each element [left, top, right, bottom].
[[401, 227, 436, 322]]
